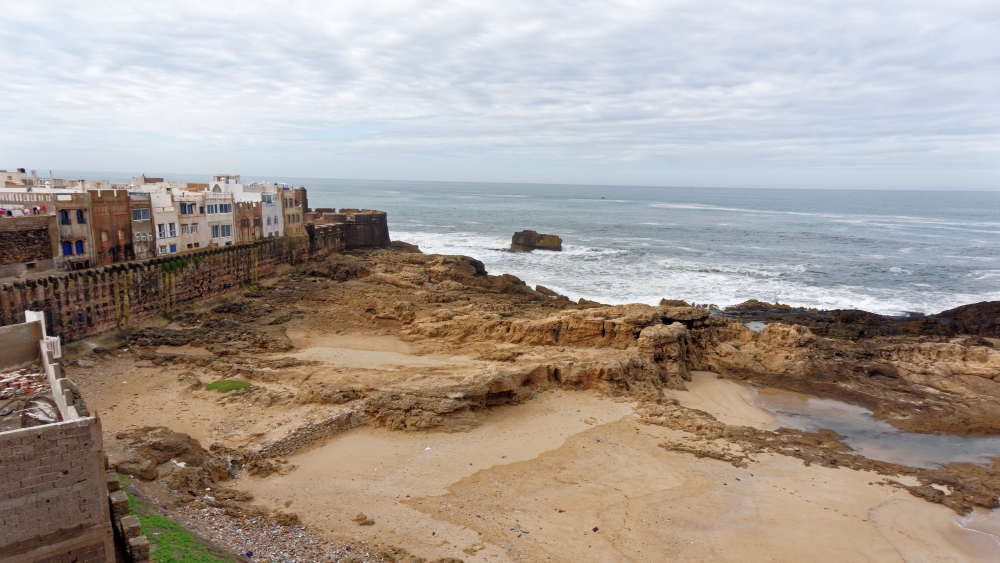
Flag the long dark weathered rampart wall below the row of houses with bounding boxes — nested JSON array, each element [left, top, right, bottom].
[[0, 225, 345, 342]]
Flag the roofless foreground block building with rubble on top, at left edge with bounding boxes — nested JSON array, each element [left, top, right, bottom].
[[0, 311, 121, 563]]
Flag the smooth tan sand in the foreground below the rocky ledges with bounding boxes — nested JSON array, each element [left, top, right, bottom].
[[229, 373, 1000, 563]]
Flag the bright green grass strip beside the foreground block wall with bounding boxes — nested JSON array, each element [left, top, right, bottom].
[[118, 475, 234, 563]]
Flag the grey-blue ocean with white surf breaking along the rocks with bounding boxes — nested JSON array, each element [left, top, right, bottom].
[[65, 172, 1000, 314]]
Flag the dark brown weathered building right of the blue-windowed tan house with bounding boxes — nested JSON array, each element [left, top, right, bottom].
[[89, 190, 136, 264]]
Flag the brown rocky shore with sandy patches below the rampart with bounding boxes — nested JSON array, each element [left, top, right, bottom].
[[62, 251, 995, 563]]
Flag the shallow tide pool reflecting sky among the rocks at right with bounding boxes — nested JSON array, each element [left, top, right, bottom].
[[755, 389, 1000, 468]]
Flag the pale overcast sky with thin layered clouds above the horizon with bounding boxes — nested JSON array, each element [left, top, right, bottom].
[[0, 0, 1000, 189]]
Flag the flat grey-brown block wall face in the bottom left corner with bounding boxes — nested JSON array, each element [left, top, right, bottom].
[[0, 418, 115, 563]]
